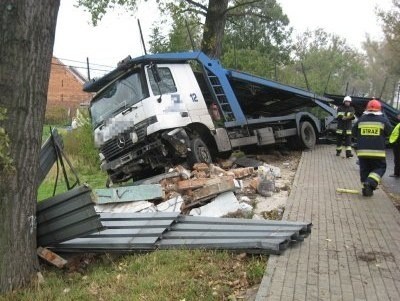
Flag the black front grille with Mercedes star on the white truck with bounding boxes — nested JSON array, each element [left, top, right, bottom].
[[100, 116, 157, 161]]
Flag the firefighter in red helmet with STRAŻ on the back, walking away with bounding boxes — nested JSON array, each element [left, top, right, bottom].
[[352, 98, 392, 196]]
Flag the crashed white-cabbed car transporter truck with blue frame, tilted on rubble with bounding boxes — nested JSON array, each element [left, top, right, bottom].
[[83, 52, 336, 183]]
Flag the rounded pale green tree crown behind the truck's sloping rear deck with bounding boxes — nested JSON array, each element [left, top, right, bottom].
[[280, 29, 366, 94]]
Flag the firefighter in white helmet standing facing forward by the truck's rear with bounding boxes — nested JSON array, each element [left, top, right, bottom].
[[336, 96, 355, 158]]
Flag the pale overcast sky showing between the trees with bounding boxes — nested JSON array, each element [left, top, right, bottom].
[[53, 0, 392, 77]]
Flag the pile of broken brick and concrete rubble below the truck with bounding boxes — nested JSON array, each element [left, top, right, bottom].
[[94, 155, 299, 219]]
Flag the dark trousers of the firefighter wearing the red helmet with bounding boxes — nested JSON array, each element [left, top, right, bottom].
[[358, 157, 386, 189]]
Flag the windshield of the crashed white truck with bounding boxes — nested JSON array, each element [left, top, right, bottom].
[[90, 69, 148, 128]]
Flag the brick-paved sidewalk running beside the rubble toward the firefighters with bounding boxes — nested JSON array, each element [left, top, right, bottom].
[[256, 145, 400, 301]]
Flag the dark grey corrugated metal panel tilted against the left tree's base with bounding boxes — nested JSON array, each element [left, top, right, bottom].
[[37, 186, 104, 247]]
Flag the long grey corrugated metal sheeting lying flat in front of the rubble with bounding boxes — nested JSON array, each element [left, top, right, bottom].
[[50, 212, 311, 254]]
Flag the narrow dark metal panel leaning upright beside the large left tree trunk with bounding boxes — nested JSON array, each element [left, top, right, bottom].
[[38, 129, 63, 183]]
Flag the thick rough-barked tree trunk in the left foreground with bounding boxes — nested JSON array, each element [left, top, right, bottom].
[[0, 0, 60, 294]]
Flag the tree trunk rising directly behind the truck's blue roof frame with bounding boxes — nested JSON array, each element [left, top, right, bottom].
[[201, 0, 229, 58]]
